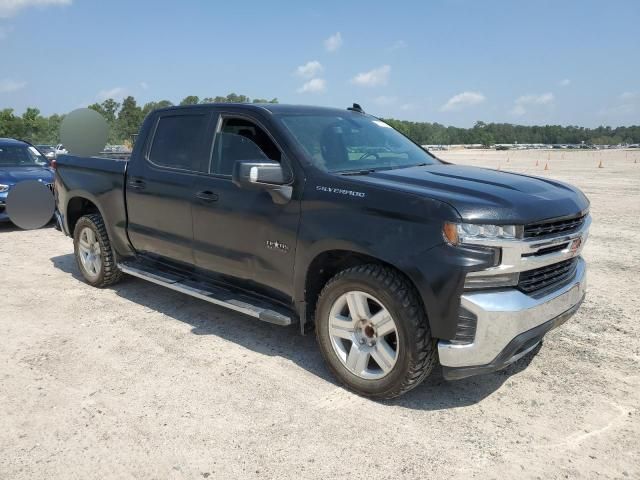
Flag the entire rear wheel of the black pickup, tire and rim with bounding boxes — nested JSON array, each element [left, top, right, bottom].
[[73, 213, 122, 287]]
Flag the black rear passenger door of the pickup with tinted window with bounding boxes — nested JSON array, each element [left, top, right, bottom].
[[126, 108, 211, 264]]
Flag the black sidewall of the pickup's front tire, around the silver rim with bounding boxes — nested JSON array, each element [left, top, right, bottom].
[[315, 272, 424, 397]]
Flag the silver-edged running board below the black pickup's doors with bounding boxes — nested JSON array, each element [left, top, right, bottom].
[[118, 263, 294, 327]]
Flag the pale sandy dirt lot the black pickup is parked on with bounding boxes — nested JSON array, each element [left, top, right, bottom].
[[0, 151, 640, 479]]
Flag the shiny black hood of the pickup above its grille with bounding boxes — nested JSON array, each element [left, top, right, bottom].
[[353, 164, 589, 224]]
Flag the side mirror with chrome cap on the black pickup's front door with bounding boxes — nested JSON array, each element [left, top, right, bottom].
[[231, 160, 293, 204]]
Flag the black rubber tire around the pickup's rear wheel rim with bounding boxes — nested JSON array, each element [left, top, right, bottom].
[[73, 213, 122, 288]]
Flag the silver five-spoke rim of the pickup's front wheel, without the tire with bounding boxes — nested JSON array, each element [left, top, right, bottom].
[[329, 291, 400, 380]]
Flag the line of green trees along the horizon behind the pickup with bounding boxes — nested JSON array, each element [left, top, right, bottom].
[[0, 93, 640, 146]]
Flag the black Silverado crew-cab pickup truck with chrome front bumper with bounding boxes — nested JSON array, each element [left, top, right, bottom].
[[55, 104, 591, 398]]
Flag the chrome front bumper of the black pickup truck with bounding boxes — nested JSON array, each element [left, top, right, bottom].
[[438, 258, 587, 380]]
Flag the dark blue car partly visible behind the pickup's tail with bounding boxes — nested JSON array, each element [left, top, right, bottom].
[[0, 138, 53, 222]]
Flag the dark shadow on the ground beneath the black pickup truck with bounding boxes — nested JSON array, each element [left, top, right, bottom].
[[51, 254, 540, 410]]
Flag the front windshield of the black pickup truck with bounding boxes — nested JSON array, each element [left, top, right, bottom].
[[280, 114, 439, 173]]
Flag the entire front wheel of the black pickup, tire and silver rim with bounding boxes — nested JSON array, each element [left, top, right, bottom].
[[316, 265, 436, 399]]
